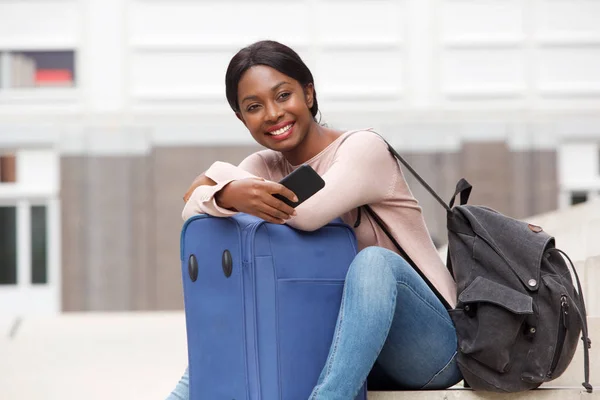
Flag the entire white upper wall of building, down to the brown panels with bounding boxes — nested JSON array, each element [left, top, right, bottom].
[[0, 0, 600, 163]]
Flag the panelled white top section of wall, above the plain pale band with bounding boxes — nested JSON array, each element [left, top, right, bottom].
[[0, 0, 600, 116]]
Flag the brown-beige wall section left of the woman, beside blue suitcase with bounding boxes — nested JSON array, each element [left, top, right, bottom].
[[61, 147, 256, 311]]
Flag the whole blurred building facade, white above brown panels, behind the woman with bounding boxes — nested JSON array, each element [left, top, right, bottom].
[[0, 0, 600, 315]]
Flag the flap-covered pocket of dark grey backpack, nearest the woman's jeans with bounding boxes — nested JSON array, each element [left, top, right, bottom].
[[450, 276, 533, 372]]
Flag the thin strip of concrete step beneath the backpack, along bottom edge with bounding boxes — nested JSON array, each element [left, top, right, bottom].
[[368, 388, 600, 400]]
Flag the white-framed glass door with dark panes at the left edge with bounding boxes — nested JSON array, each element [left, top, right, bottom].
[[0, 150, 61, 317]]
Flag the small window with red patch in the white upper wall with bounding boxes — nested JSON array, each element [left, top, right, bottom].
[[0, 51, 76, 89]]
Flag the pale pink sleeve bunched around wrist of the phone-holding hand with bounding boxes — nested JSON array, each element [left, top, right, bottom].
[[182, 153, 269, 221]]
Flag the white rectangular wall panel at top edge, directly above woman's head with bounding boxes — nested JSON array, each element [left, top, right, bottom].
[[129, 1, 313, 47]]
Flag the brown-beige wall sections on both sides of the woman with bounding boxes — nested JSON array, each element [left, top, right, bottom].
[[61, 142, 558, 311]]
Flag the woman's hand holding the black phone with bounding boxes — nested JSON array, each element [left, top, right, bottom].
[[215, 178, 298, 224]]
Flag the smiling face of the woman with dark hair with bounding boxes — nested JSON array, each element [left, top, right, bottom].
[[237, 65, 314, 152]]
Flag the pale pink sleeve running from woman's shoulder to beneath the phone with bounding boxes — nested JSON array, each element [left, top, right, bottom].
[[287, 131, 399, 231]]
